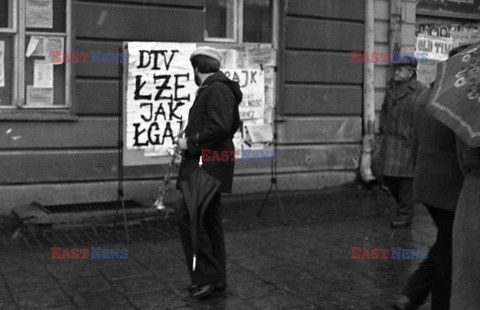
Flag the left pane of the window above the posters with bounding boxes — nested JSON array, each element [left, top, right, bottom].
[[205, 0, 235, 39]]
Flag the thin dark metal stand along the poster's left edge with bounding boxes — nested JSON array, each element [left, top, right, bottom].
[[113, 46, 130, 242]]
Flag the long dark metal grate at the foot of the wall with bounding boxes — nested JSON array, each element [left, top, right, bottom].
[[40, 200, 144, 214]]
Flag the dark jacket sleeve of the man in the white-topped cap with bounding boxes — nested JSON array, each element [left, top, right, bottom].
[[187, 82, 237, 154]]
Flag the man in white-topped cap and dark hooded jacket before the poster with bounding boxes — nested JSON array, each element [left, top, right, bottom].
[[177, 47, 242, 298]]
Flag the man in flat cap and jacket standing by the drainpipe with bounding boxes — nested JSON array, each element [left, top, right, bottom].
[[380, 56, 425, 227]]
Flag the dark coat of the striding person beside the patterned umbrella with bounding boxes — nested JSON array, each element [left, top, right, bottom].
[[413, 88, 463, 211]]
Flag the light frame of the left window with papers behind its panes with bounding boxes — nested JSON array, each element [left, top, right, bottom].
[[0, 0, 73, 116]]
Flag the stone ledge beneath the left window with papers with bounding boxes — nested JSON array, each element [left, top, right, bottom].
[[0, 109, 79, 122]]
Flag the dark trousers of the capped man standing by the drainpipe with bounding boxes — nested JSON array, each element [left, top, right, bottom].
[[384, 176, 413, 221]]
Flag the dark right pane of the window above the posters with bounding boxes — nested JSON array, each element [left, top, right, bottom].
[[243, 0, 272, 43]]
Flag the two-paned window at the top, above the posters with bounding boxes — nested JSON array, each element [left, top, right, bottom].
[[205, 0, 277, 43]]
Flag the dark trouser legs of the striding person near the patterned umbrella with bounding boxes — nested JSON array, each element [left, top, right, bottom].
[[404, 205, 455, 310]]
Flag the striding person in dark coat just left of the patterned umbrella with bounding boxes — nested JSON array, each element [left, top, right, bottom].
[[394, 44, 463, 310]]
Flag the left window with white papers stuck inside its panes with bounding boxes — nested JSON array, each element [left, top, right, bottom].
[[0, 0, 71, 109]]
